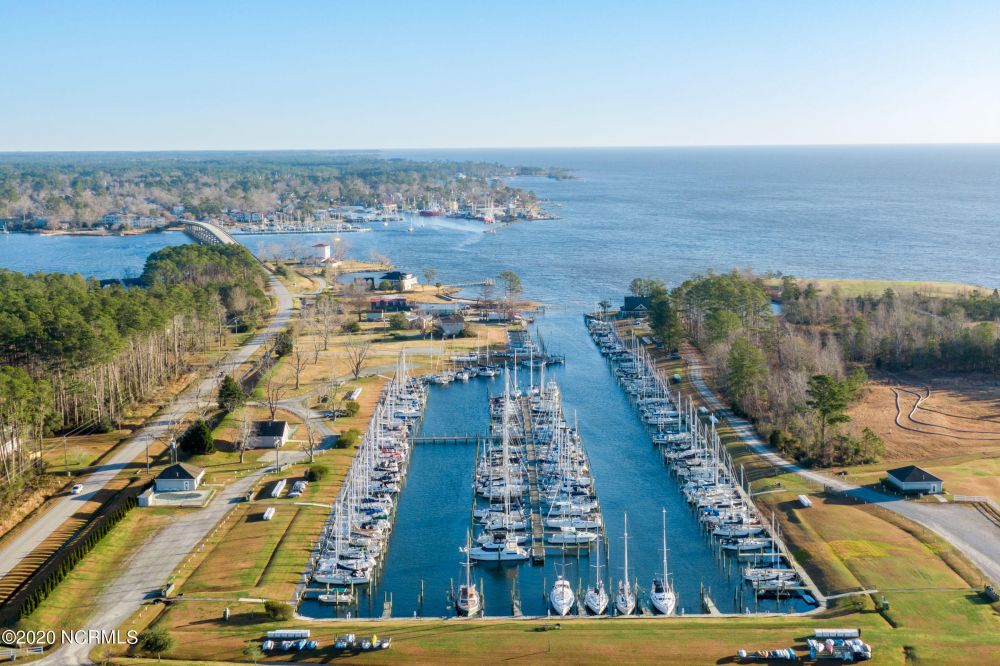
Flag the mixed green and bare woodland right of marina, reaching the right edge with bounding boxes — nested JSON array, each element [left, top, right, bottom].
[[630, 271, 1000, 466]]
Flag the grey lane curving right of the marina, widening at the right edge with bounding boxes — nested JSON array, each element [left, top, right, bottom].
[[688, 363, 1000, 582]]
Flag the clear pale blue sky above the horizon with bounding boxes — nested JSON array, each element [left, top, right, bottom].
[[0, 0, 1000, 151]]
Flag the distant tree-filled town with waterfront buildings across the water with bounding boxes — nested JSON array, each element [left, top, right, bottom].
[[0, 153, 572, 234]]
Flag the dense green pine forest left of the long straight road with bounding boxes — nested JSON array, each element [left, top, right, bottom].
[[0, 245, 268, 499]]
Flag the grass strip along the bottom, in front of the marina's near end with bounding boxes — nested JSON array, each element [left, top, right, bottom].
[[107, 591, 1000, 664]]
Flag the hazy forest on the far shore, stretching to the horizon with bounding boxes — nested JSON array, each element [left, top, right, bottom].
[[0, 152, 565, 226]]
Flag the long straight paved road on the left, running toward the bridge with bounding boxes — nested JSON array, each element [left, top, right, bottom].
[[0, 276, 292, 578]]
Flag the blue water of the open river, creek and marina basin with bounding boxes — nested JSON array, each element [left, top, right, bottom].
[[0, 146, 1000, 615]]
